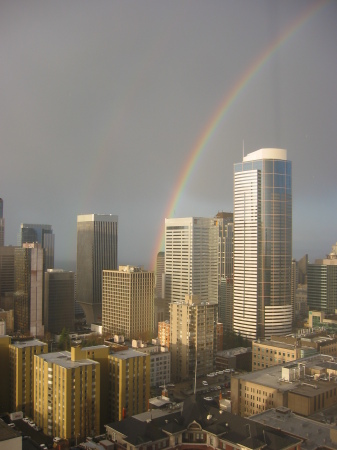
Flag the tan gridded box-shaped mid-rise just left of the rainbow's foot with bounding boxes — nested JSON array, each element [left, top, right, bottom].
[[102, 266, 154, 339]]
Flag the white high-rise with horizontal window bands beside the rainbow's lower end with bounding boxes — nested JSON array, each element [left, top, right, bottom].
[[165, 217, 219, 304]]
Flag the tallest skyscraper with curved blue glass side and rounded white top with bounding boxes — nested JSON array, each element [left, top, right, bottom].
[[233, 148, 292, 339]]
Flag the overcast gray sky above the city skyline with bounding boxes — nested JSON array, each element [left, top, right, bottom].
[[0, 0, 337, 267]]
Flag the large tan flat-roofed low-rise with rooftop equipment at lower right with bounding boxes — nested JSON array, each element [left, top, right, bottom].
[[231, 354, 337, 417]]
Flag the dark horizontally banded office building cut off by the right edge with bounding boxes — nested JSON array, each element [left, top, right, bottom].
[[307, 245, 337, 314]]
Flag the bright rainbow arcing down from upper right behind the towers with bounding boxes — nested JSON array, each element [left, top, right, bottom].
[[151, 0, 331, 270]]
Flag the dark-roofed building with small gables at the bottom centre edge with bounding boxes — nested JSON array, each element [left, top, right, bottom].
[[106, 396, 301, 450]]
